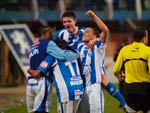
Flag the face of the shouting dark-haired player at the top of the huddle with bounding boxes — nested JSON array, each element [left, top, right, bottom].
[[62, 17, 76, 33]]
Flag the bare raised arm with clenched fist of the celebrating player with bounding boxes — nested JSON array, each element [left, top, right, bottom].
[[85, 10, 109, 43]]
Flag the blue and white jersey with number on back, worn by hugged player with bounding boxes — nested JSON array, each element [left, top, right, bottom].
[[38, 55, 84, 103]]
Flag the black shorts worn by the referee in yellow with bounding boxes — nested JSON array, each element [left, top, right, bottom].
[[124, 83, 150, 112]]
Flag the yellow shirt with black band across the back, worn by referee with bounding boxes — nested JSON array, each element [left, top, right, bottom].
[[113, 42, 150, 83]]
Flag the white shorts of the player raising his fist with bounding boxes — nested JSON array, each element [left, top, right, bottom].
[[86, 83, 104, 113]]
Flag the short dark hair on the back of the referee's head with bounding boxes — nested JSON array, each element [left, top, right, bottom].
[[133, 27, 146, 42]]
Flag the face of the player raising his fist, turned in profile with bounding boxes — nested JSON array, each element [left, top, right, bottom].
[[82, 28, 94, 42]]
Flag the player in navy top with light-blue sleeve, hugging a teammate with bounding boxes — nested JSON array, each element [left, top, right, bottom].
[[27, 26, 78, 112]]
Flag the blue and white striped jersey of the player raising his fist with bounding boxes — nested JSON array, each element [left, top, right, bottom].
[[77, 41, 105, 85]]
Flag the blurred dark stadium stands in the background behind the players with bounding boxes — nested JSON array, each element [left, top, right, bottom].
[[0, 0, 150, 86]]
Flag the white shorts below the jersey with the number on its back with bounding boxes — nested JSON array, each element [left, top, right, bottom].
[[58, 99, 81, 113]]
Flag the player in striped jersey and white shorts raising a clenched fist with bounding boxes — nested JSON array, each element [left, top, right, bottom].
[[77, 11, 109, 113]]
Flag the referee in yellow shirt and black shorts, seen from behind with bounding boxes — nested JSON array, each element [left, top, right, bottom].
[[113, 28, 150, 113]]
